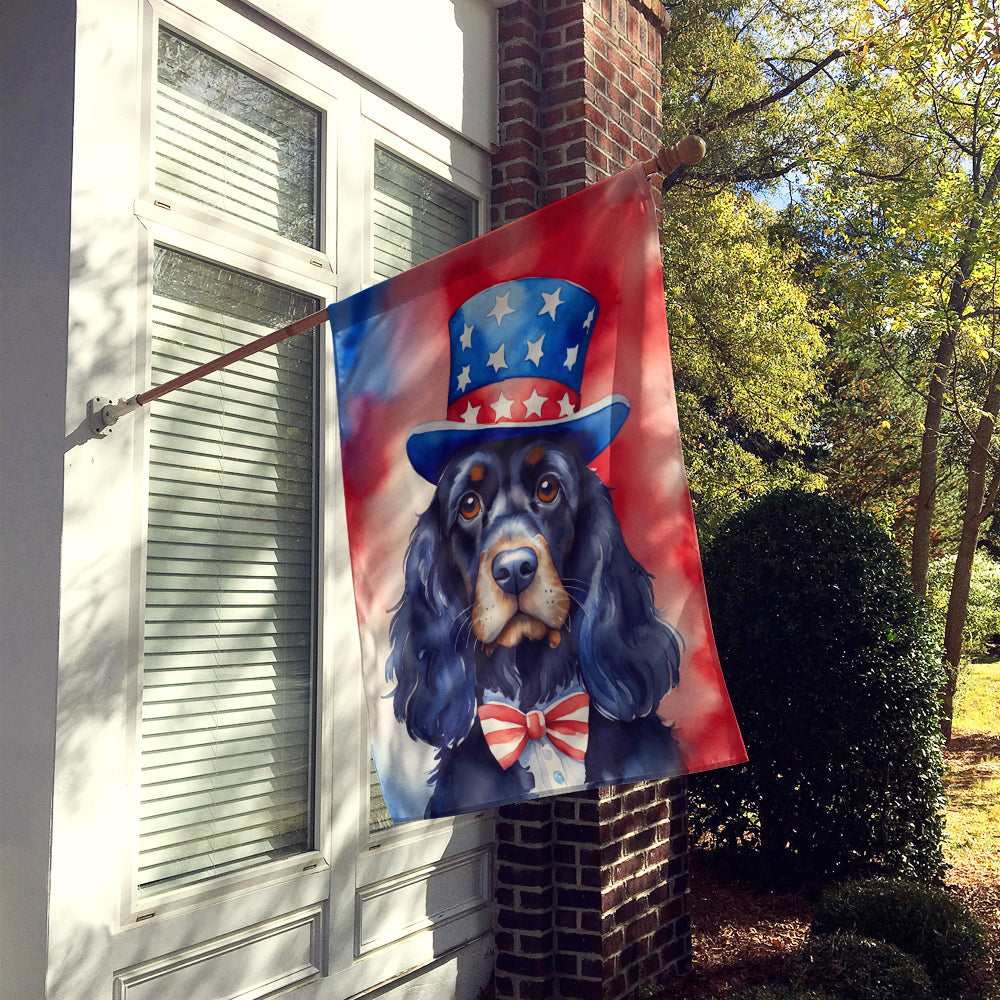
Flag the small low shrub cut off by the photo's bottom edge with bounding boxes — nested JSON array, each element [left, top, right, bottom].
[[793, 934, 934, 1000]]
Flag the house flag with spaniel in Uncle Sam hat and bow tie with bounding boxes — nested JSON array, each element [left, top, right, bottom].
[[329, 167, 746, 822]]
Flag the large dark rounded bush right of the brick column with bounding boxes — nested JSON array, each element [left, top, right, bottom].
[[691, 490, 944, 880]]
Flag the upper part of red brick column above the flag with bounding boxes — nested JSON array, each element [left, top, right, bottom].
[[493, 0, 669, 226]]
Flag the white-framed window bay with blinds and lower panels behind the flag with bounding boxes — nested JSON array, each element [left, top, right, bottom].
[[114, 7, 492, 1000]]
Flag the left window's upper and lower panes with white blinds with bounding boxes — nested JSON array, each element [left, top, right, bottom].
[[137, 27, 320, 899]]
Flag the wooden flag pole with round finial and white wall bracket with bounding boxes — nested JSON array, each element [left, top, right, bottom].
[[87, 135, 705, 437]]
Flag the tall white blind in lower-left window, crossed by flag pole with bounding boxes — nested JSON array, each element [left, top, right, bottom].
[[138, 247, 318, 895]]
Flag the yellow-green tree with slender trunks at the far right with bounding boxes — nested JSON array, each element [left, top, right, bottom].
[[810, 0, 1000, 734]]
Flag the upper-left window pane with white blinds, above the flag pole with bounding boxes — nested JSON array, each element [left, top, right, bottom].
[[154, 26, 320, 248]]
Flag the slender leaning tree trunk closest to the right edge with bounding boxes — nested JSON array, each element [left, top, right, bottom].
[[941, 372, 1000, 740]]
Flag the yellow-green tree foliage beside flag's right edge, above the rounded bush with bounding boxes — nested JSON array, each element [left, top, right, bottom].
[[663, 192, 824, 535]]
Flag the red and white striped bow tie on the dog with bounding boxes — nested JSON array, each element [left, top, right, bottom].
[[479, 692, 590, 771]]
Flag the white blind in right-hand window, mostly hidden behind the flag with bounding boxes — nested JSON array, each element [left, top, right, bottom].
[[368, 146, 478, 832]]
